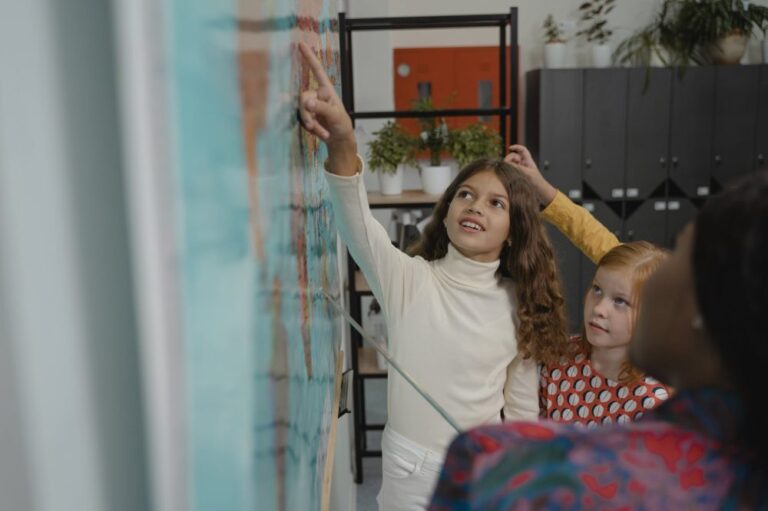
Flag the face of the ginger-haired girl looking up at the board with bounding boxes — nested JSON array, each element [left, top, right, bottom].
[[584, 267, 635, 348]]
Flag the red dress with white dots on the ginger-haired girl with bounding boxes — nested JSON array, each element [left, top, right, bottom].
[[539, 354, 669, 427]]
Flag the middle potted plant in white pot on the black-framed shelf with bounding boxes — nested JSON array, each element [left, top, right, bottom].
[[414, 97, 451, 195]]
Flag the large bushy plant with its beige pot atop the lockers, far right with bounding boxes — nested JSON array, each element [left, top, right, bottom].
[[662, 0, 768, 65]]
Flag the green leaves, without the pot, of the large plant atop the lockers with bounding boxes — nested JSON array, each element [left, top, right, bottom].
[[660, 0, 768, 66]]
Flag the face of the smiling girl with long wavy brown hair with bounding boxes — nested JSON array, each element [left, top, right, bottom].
[[443, 170, 509, 262]]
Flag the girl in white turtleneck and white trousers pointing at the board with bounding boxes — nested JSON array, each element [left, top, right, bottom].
[[300, 44, 567, 510]]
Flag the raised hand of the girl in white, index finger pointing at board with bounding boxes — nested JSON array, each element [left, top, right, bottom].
[[299, 42, 357, 174]]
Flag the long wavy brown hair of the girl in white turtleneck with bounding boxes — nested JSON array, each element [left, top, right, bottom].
[[408, 159, 568, 364]]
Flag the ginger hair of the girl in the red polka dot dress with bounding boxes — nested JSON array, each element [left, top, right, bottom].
[[570, 241, 668, 384]]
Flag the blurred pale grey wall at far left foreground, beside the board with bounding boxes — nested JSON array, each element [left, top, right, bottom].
[[0, 0, 148, 511]]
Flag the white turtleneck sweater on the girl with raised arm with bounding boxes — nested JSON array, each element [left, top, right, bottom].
[[326, 164, 539, 455]]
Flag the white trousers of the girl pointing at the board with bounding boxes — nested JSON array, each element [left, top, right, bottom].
[[376, 427, 443, 511]]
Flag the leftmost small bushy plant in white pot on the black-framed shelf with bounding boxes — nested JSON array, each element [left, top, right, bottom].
[[368, 121, 417, 195]]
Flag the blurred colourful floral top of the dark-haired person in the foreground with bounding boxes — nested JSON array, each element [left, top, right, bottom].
[[429, 389, 768, 511]]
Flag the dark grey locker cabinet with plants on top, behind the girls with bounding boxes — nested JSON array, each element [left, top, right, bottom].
[[525, 65, 768, 336]]
